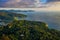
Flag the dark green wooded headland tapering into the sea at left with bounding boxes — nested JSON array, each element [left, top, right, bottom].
[[0, 11, 27, 20]]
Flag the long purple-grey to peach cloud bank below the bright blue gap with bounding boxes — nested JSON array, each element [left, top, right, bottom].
[[2, 0, 60, 8]]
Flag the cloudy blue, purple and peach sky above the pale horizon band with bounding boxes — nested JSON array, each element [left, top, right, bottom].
[[0, 0, 60, 10]]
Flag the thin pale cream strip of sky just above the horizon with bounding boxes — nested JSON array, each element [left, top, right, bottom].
[[0, 8, 60, 11]]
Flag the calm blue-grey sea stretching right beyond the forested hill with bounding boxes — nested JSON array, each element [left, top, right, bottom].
[[17, 11, 60, 30]]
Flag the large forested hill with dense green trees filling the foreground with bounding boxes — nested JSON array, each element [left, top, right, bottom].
[[0, 20, 60, 40]]
